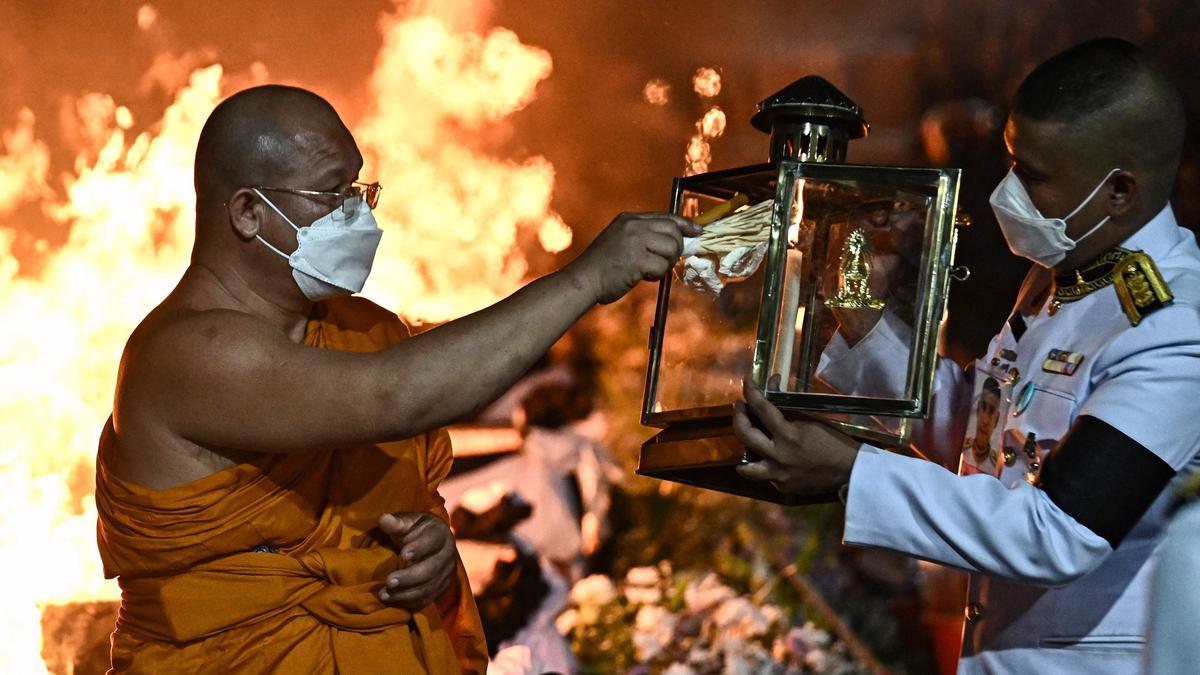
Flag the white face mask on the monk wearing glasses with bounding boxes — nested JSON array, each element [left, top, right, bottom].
[[252, 187, 383, 301]]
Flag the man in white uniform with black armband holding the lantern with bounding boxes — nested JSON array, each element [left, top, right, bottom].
[[734, 38, 1200, 675]]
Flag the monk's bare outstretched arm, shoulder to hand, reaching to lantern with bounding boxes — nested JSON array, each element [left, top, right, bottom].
[[118, 214, 697, 452]]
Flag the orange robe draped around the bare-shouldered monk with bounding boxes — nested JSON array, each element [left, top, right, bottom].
[[96, 298, 487, 675]]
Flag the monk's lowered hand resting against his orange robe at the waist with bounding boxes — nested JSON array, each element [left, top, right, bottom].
[[379, 512, 458, 611]]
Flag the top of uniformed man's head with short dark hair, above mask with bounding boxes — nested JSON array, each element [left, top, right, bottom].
[[1013, 37, 1187, 203]]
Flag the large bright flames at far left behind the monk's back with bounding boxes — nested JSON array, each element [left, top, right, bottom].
[[0, 61, 221, 673]]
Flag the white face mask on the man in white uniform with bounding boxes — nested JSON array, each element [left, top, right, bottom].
[[988, 168, 1121, 267]]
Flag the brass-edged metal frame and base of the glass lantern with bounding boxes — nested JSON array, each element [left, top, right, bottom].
[[638, 159, 960, 503]]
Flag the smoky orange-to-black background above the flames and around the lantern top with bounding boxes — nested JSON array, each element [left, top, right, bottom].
[[0, 0, 1200, 359]]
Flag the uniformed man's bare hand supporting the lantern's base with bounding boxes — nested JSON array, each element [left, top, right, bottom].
[[733, 380, 859, 496]]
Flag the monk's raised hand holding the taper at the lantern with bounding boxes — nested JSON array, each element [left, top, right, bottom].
[[569, 213, 701, 304]]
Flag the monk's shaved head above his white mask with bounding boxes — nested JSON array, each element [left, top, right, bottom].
[[196, 84, 356, 222]]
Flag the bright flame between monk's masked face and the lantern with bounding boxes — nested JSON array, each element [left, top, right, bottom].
[[358, 5, 571, 321]]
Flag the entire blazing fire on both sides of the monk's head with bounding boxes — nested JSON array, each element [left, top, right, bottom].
[[0, 4, 571, 673]]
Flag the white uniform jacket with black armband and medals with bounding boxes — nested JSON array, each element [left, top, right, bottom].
[[822, 205, 1200, 675]]
